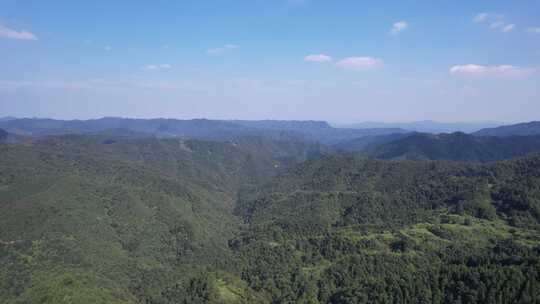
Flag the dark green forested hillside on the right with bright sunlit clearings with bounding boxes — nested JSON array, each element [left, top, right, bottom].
[[235, 155, 540, 303]]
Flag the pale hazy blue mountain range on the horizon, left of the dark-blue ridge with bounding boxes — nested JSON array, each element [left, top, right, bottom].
[[0, 117, 405, 144]]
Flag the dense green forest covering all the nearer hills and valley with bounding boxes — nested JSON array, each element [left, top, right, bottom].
[[0, 120, 540, 304]]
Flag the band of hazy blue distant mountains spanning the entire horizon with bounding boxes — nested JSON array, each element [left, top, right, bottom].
[[0, 117, 540, 162]]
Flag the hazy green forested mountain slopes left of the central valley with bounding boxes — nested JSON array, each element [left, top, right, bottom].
[[0, 135, 321, 303]]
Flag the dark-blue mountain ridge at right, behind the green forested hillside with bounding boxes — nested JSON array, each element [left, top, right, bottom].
[[364, 132, 540, 162]]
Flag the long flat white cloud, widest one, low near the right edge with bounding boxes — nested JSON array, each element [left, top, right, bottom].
[[450, 64, 535, 77]]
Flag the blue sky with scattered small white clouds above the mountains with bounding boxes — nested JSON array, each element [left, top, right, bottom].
[[0, 0, 540, 122]]
